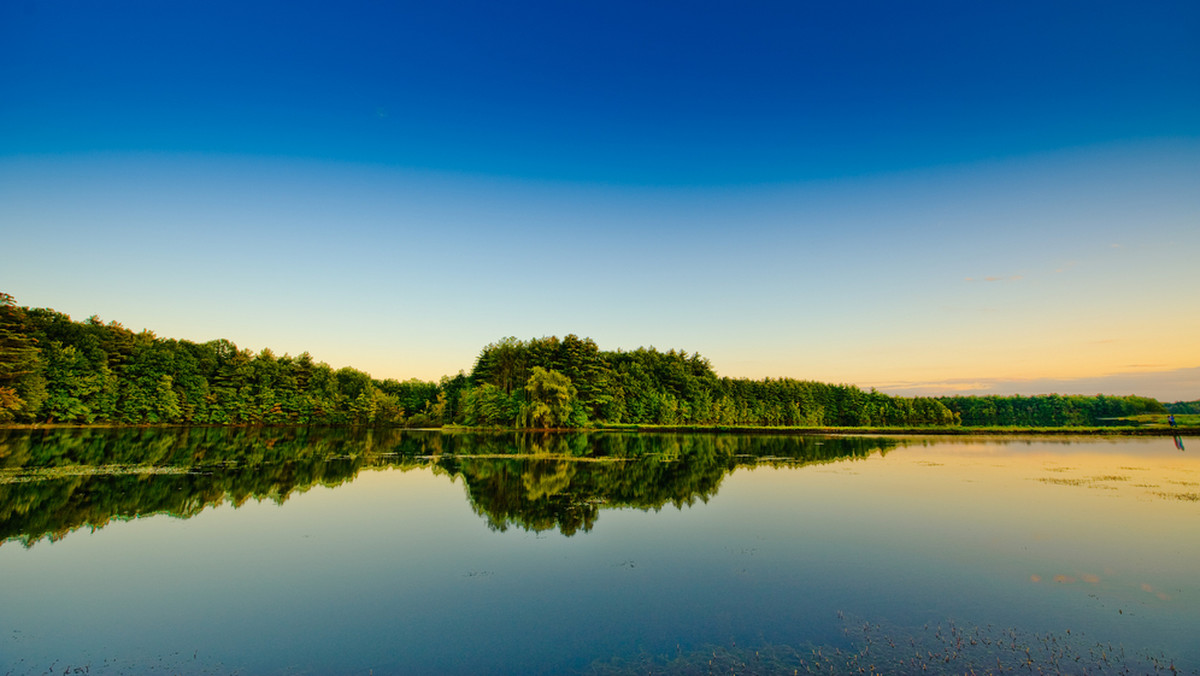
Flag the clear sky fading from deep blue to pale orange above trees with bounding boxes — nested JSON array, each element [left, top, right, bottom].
[[0, 0, 1200, 401]]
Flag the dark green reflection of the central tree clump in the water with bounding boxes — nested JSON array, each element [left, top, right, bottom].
[[438, 433, 893, 536]]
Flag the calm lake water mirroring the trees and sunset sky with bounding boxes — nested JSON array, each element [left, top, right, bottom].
[[0, 429, 1200, 674]]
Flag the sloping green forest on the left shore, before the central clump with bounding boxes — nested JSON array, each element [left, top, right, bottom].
[[0, 294, 440, 426]]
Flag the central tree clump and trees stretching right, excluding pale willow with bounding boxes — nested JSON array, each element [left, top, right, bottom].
[[448, 335, 1166, 427]]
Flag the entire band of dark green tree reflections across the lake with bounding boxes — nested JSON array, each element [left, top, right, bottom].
[[0, 427, 894, 546]]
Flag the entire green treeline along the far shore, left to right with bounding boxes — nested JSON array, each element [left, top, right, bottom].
[[0, 293, 1166, 429]]
